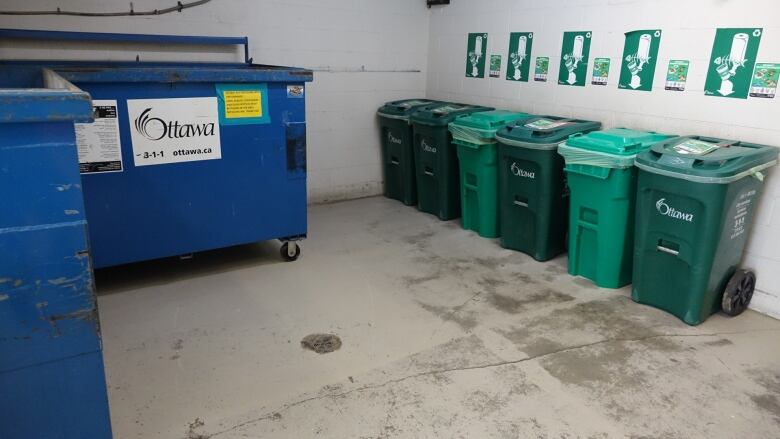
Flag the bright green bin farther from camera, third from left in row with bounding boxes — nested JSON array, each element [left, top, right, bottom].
[[449, 110, 531, 238]]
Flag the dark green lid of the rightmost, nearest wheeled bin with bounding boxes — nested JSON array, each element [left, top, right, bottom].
[[636, 136, 778, 183]]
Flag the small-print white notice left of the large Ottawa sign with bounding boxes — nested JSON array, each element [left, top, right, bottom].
[[74, 100, 122, 174]]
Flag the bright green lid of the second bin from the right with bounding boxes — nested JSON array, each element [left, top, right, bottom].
[[566, 128, 676, 156]]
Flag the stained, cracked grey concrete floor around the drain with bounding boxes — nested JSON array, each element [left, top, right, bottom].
[[97, 198, 780, 439]]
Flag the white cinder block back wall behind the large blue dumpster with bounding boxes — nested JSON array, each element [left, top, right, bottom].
[[0, 0, 428, 202]]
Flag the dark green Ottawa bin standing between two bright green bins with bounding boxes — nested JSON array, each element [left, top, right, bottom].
[[496, 116, 601, 261]]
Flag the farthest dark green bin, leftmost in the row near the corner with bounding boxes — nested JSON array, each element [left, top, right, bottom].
[[376, 99, 436, 206]]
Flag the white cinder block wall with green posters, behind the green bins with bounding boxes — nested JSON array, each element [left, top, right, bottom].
[[427, 0, 780, 317]]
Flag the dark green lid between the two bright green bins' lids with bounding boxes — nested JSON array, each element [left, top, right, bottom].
[[496, 116, 601, 149]]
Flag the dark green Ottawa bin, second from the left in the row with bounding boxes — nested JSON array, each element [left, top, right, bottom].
[[410, 103, 492, 221]]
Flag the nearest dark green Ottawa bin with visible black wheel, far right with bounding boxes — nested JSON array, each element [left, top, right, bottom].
[[632, 136, 778, 325]]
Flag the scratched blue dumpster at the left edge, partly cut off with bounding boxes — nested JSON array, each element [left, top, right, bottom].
[[0, 69, 111, 439]]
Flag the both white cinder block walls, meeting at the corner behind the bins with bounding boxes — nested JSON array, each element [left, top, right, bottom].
[[0, 0, 780, 317]]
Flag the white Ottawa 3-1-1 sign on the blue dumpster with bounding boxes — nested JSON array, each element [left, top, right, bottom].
[[127, 97, 222, 166]]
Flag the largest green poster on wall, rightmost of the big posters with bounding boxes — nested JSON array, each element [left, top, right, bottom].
[[704, 27, 763, 99]]
